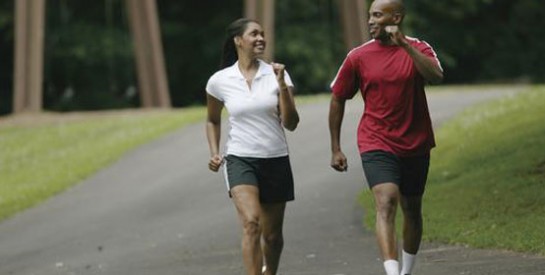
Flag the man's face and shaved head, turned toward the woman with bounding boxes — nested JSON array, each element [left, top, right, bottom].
[[368, 0, 397, 41]]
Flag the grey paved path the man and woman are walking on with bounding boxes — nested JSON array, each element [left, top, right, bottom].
[[0, 87, 545, 275]]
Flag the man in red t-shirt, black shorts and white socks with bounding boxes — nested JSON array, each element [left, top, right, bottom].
[[329, 0, 443, 275]]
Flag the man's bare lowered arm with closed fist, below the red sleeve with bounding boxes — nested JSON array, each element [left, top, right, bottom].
[[329, 95, 348, 172]]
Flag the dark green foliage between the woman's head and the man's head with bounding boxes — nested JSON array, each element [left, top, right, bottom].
[[275, 0, 347, 93]]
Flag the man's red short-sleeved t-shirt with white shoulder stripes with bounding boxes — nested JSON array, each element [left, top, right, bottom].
[[331, 38, 439, 156]]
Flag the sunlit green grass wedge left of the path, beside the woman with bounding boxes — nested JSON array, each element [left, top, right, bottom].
[[0, 108, 205, 220]]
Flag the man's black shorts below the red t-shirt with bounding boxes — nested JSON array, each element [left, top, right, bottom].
[[361, 151, 430, 196]]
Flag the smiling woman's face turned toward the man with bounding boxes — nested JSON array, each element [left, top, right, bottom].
[[235, 22, 266, 58]]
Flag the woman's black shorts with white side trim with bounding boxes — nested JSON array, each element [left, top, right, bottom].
[[225, 155, 295, 203]]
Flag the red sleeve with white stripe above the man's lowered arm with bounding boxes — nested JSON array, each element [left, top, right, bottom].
[[331, 55, 359, 99]]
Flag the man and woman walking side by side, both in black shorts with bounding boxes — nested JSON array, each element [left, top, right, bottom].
[[206, 0, 443, 275]]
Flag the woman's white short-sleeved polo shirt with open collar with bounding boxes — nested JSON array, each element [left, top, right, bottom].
[[206, 60, 293, 158]]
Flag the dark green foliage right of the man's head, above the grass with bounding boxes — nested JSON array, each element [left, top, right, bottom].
[[406, 0, 545, 82]]
